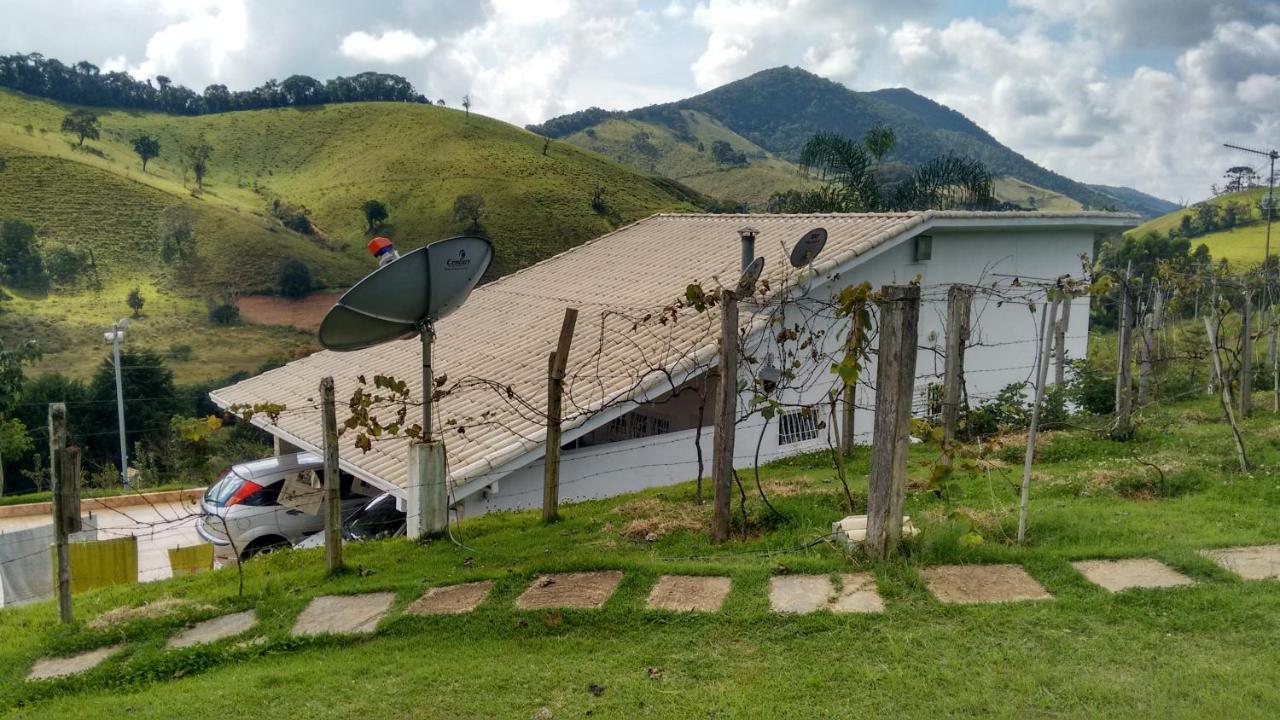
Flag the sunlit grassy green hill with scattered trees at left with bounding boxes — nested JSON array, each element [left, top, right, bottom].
[[0, 91, 707, 378]]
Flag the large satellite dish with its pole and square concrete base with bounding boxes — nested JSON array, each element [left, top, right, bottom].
[[319, 236, 493, 539]]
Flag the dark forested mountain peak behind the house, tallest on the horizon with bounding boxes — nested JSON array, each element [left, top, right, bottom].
[[530, 67, 1169, 215]]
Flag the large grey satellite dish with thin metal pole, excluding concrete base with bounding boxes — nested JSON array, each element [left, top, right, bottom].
[[319, 236, 493, 439]]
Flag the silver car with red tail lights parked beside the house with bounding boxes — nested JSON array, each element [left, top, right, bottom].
[[196, 452, 376, 562]]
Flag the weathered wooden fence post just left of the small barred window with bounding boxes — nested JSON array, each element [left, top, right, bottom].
[[712, 290, 737, 543]]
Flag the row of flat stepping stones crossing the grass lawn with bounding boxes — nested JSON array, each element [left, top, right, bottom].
[[27, 544, 1280, 680]]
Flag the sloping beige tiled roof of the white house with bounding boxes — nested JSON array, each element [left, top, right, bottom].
[[212, 211, 1132, 487]]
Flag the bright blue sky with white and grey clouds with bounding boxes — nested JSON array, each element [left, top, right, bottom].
[[0, 0, 1280, 201]]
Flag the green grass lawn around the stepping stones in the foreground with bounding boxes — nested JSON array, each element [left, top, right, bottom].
[[0, 401, 1280, 719]]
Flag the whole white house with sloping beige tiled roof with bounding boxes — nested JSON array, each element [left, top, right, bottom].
[[204, 211, 1137, 516]]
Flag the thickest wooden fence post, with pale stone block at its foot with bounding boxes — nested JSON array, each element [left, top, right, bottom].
[[867, 284, 920, 560]]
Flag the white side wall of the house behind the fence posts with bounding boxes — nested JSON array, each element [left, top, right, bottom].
[[461, 228, 1093, 516]]
